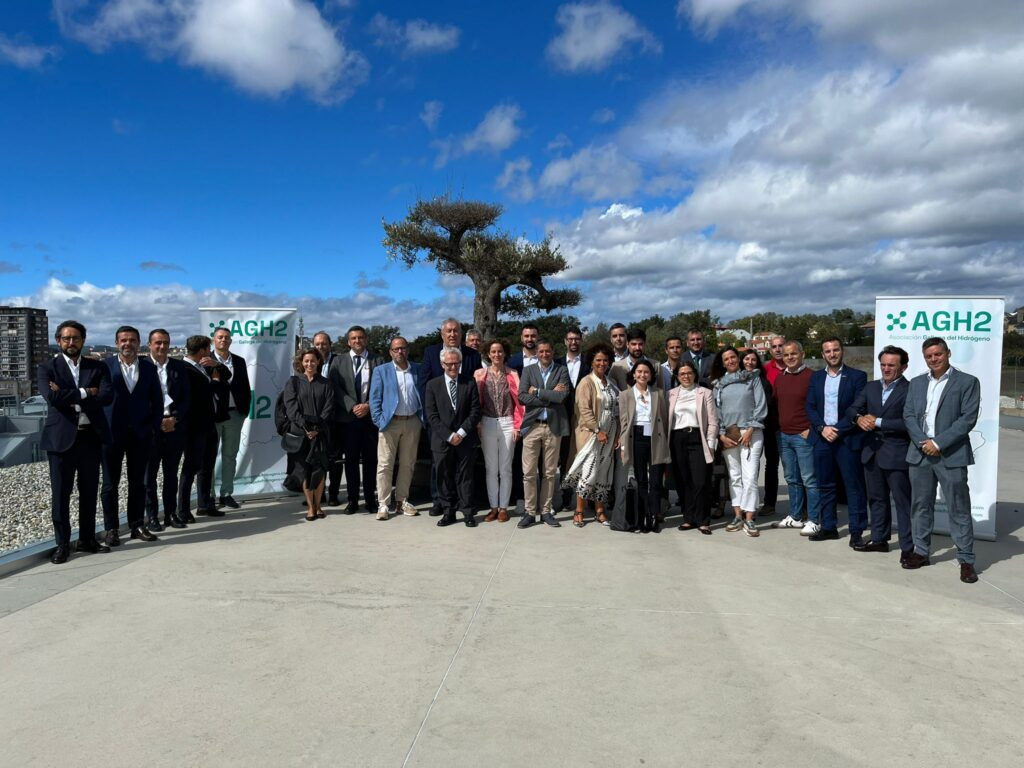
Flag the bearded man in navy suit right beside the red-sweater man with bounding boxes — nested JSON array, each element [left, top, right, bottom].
[[804, 337, 867, 547]]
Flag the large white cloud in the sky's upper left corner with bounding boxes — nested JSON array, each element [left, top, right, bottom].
[[54, 0, 369, 103]]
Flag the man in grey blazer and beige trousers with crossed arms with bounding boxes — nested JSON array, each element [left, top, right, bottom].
[[519, 339, 571, 528]]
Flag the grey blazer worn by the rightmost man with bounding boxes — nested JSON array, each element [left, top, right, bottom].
[[903, 368, 981, 467]]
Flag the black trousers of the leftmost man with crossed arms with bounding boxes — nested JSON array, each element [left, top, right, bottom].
[[46, 428, 100, 547]]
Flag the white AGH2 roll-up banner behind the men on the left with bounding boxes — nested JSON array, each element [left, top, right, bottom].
[[199, 307, 298, 496]]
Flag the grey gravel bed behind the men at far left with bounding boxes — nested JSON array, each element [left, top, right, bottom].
[[0, 462, 163, 555]]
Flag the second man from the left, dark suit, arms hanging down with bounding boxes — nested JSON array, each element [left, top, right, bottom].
[[99, 326, 164, 547]]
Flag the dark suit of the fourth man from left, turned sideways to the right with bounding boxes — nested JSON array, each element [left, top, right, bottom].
[[178, 358, 228, 521]]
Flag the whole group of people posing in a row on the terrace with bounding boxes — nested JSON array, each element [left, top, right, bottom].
[[39, 318, 980, 583]]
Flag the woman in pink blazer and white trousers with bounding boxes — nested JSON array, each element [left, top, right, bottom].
[[473, 340, 524, 522]]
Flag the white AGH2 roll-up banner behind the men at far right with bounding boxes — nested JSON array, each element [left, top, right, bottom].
[[874, 296, 1006, 541]]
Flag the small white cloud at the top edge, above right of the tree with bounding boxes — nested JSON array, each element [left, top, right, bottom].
[[547, 0, 662, 72]]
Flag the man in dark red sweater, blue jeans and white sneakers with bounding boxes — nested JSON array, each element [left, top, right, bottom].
[[772, 341, 821, 536]]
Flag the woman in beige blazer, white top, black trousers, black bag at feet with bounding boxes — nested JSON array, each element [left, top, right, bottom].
[[611, 359, 670, 534]]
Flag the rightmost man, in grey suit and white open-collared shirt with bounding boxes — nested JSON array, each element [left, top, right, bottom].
[[903, 338, 981, 584]]
